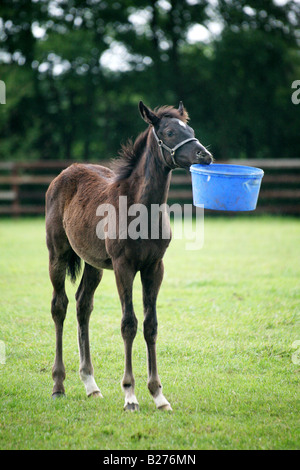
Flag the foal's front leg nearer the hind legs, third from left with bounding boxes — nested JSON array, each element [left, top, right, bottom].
[[113, 259, 139, 411]]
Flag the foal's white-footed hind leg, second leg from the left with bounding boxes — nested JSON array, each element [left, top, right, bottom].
[[76, 263, 103, 397]]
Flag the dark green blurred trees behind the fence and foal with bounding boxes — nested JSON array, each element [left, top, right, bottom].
[[0, 0, 300, 160]]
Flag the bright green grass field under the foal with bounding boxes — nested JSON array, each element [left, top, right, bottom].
[[0, 217, 300, 450]]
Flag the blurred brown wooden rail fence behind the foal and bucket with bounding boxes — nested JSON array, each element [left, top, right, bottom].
[[0, 159, 300, 216]]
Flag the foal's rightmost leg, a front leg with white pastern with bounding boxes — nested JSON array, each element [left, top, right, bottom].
[[141, 260, 172, 411]]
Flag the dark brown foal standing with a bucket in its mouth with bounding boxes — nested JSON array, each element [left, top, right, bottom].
[[46, 102, 212, 410]]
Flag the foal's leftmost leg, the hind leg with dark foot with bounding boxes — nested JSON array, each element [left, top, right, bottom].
[[49, 254, 68, 398]]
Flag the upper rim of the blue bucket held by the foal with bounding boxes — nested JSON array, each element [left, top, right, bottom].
[[190, 163, 264, 178]]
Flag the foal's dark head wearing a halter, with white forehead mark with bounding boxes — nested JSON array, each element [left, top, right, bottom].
[[139, 101, 213, 169]]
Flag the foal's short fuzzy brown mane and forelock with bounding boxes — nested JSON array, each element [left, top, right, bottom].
[[113, 106, 188, 181]]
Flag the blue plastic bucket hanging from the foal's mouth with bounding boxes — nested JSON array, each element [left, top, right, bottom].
[[190, 163, 264, 211]]
